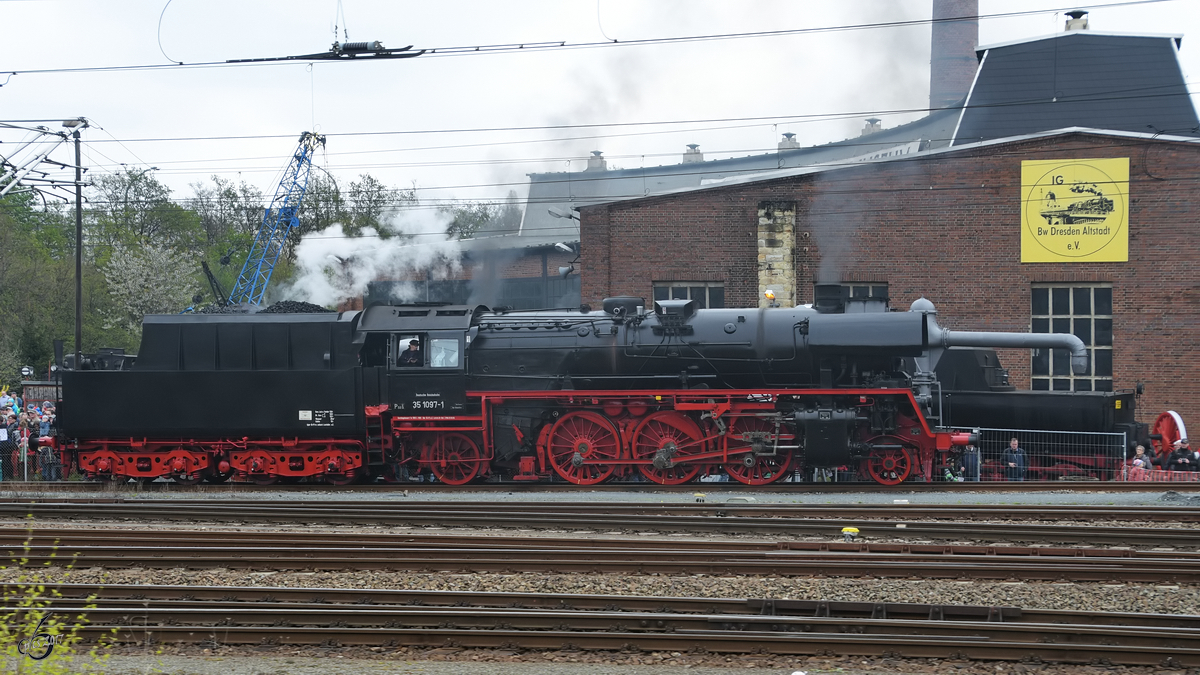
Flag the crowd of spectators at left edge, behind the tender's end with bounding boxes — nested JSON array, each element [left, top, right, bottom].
[[0, 390, 62, 480]]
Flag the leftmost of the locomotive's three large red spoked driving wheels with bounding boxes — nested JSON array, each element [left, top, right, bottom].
[[547, 411, 620, 485]]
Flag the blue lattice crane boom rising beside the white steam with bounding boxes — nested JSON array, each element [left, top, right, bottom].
[[229, 131, 325, 305]]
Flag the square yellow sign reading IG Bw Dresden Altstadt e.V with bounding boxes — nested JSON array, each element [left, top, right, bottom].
[[1021, 157, 1129, 263]]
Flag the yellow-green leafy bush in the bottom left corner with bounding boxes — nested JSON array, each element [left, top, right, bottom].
[[0, 516, 115, 675]]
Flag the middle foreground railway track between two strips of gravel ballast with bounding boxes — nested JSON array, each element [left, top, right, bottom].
[[7, 528, 1200, 584]]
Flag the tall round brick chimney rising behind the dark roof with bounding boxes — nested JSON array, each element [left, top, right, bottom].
[[929, 0, 979, 110]]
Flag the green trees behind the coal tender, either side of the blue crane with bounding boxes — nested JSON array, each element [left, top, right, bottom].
[[0, 169, 416, 357]]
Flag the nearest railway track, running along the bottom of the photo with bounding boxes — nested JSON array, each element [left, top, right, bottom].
[[5, 584, 1200, 667]]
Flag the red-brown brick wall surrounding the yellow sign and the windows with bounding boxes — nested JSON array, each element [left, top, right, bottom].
[[581, 133, 1200, 429]]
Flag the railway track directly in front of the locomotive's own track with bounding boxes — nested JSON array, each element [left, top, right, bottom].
[[0, 498, 1200, 548]]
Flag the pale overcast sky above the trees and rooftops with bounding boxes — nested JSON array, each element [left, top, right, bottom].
[[0, 0, 1200, 203]]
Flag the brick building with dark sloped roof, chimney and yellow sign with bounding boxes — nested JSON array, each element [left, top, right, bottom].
[[566, 10, 1200, 424]]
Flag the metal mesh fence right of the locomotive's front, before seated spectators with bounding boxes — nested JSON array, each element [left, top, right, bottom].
[[934, 429, 1128, 480]]
